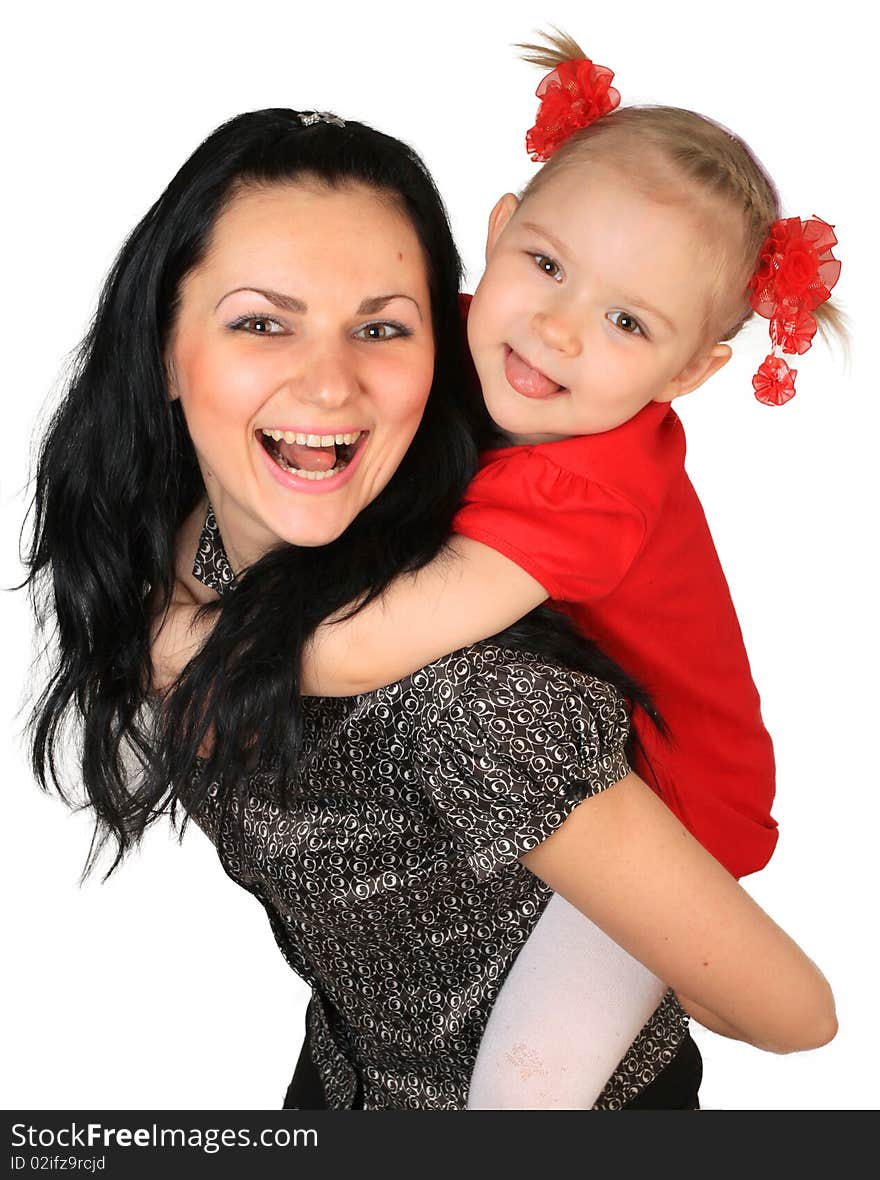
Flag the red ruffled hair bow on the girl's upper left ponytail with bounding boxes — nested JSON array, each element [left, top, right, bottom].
[[526, 58, 620, 164]]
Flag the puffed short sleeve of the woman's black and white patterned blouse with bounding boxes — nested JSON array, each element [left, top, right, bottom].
[[418, 645, 629, 879]]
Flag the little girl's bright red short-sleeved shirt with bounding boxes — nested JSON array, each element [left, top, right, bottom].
[[454, 402, 777, 877]]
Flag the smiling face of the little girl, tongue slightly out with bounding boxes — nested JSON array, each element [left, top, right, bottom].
[[468, 165, 730, 443]]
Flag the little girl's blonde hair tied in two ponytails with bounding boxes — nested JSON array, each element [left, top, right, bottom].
[[517, 30, 846, 341]]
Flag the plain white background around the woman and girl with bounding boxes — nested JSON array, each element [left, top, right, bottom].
[[0, 0, 880, 1109]]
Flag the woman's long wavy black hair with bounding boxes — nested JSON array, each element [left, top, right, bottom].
[[27, 109, 655, 872]]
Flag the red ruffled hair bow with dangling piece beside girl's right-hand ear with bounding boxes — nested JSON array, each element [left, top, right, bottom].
[[749, 217, 840, 406]]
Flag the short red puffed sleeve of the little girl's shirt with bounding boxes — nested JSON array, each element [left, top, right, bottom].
[[453, 447, 646, 603]]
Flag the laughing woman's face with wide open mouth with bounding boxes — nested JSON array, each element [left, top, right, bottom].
[[168, 181, 434, 569]]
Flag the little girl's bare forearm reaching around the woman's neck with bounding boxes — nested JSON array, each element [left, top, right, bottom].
[[302, 537, 547, 696]]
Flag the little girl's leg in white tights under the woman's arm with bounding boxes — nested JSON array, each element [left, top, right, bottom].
[[467, 893, 666, 1110]]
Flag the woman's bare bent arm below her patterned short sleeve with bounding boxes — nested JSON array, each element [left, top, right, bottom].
[[520, 774, 838, 1053]]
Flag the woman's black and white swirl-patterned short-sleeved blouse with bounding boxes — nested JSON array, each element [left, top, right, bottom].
[[188, 511, 688, 1110]]
